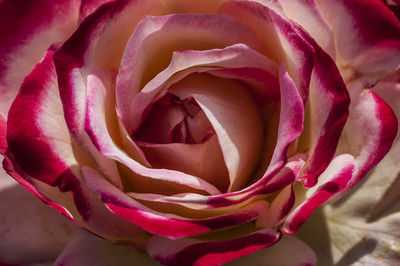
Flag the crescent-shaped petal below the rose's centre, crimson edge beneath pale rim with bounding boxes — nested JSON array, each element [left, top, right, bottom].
[[82, 167, 268, 239]]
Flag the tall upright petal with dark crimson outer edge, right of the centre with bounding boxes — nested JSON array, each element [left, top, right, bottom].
[[297, 28, 350, 187]]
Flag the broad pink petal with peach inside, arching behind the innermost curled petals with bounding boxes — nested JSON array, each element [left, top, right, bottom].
[[116, 14, 266, 132]]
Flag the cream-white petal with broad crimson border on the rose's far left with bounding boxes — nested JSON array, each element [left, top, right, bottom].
[[7, 51, 83, 185]]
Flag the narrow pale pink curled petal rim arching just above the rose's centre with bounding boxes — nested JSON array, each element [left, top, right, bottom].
[[126, 44, 278, 135]]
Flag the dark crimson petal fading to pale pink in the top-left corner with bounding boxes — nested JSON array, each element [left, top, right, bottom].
[[0, 0, 80, 117]]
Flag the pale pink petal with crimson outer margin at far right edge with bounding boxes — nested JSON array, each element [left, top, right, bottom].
[[337, 81, 398, 191]]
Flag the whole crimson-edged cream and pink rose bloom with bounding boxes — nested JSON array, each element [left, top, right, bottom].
[[0, 0, 400, 265]]
